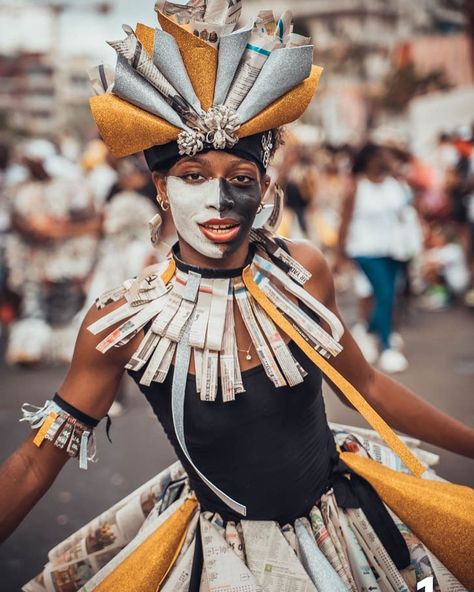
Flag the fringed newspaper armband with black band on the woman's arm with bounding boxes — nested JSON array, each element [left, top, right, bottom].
[[19, 393, 99, 469]]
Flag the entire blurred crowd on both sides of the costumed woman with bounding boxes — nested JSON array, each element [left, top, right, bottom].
[[0, 130, 474, 372]]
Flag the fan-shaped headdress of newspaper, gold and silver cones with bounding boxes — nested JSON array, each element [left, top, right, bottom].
[[90, 0, 322, 168]]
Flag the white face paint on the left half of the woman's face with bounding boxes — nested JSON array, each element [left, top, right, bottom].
[[166, 176, 226, 259]]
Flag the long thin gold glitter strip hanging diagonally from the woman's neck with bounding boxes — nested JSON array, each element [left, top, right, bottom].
[[242, 267, 425, 477]]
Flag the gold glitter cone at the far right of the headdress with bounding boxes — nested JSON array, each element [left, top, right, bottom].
[[237, 66, 323, 138]]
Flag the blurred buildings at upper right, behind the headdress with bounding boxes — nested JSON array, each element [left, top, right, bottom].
[[246, 0, 474, 144]]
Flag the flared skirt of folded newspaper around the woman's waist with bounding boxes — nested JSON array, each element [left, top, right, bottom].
[[22, 425, 465, 592]]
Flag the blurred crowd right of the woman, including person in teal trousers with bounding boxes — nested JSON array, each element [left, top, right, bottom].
[[273, 128, 474, 373]]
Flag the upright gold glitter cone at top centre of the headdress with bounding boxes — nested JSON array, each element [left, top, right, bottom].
[[158, 12, 217, 110]]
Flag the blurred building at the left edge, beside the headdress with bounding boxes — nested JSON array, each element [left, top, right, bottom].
[[0, 52, 90, 135]]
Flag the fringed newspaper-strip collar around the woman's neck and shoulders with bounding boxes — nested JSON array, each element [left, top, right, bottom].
[[88, 249, 343, 402]]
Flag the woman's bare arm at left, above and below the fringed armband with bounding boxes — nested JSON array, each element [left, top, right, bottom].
[[0, 302, 140, 542]]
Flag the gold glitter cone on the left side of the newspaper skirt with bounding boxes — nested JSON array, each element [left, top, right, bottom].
[[95, 498, 197, 592]]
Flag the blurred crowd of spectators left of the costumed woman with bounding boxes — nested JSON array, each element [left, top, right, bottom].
[[0, 139, 174, 365]]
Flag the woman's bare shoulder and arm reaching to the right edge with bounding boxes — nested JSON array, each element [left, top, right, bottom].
[[289, 241, 474, 458]]
